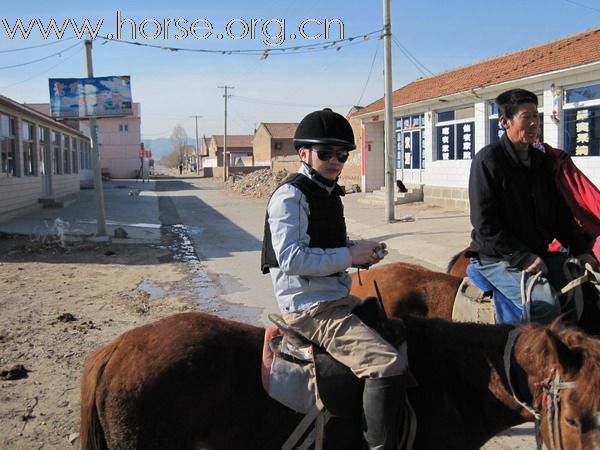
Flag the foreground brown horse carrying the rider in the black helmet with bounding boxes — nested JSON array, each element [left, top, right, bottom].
[[81, 313, 600, 450]]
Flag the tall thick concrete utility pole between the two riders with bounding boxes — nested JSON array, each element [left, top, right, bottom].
[[383, 0, 396, 222]]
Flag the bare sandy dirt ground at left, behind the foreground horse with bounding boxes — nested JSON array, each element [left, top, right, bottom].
[[0, 237, 190, 450]]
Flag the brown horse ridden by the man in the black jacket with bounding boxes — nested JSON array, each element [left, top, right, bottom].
[[351, 260, 600, 335]]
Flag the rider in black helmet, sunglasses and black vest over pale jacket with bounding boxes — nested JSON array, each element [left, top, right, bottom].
[[261, 109, 407, 449]]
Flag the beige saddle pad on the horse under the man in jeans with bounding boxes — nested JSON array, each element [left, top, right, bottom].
[[452, 277, 496, 324]]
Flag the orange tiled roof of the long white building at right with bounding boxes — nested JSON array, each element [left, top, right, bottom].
[[358, 28, 600, 115]]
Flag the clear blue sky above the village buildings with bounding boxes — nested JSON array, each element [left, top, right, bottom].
[[0, 0, 600, 139]]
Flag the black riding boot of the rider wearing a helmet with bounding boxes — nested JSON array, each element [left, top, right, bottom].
[[363, 375, 404, 450]]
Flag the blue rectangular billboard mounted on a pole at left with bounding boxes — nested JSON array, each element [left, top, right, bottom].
[[48, 76, 133, 119]]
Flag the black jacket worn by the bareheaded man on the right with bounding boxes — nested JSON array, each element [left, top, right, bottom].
[[469, 134, 590, 268]]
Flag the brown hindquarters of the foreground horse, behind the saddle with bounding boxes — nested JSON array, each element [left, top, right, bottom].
[[82, 313, 298, 449]]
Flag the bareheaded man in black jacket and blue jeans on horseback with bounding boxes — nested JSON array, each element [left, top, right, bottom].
[[469, 89, 598, 322]]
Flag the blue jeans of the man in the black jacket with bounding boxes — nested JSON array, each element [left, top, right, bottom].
[[471, 252, 567, 323]]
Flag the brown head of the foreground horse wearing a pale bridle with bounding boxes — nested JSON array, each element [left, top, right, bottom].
[[515, 320, 600, 450]]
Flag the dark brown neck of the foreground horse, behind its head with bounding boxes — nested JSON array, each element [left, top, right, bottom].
[[405, 316, 526, 442]]
